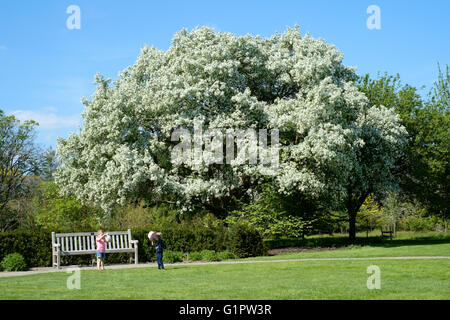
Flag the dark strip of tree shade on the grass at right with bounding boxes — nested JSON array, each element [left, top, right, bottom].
[[264, 234, 450, 250]]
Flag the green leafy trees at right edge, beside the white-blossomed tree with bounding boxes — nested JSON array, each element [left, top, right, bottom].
[[358, 66, 450, 234]]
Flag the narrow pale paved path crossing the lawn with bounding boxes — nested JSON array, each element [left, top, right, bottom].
[[0, 256, 450, 278]]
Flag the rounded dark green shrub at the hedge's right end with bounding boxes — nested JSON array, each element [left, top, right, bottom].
[[226, 223, 266, 258]]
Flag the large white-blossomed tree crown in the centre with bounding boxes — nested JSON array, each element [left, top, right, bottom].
[[56, 28, 404, 239]]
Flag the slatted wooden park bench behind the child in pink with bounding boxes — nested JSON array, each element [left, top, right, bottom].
[[52, 229, 138, 269]]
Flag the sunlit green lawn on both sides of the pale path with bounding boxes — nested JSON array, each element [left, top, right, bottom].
[[0, 232, 450, 300]]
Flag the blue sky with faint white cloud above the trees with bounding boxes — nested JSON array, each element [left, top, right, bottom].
[[0, 0, 450, 148]]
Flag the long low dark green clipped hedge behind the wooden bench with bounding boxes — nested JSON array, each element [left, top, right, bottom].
[[0, 225, 265, 267]]
